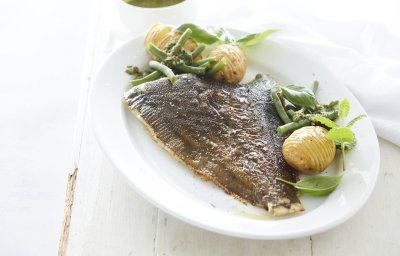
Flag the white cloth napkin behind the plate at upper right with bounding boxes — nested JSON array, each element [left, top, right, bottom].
[[105, 0, 400, 146]]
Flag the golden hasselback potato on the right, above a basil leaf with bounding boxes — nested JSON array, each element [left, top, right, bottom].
[[282, 126, 336, 174]]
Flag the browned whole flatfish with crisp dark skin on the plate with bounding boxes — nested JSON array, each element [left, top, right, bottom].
[[124, 74, 303, 216]]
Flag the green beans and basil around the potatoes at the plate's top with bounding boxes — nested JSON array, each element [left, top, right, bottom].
[[126, 23, 276, 86]]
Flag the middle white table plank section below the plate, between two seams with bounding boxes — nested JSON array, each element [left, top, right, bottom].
[[155, 211, 311, 256]]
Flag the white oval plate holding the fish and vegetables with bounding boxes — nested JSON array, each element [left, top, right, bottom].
[[90, 28, 379, 239]]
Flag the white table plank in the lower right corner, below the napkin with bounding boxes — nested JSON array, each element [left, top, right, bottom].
[[313, 139, 400, 256]]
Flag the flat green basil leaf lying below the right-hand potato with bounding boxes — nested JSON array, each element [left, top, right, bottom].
[[276, 176, 342, 196]]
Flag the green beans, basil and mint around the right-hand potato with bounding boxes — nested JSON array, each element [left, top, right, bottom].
[[271, 81, 366, 196]]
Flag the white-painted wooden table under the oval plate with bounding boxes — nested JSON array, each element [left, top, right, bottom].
[[60, 1, 400, 256]]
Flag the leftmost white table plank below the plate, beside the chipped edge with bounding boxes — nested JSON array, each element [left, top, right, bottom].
[[68, 134, 158, 255]]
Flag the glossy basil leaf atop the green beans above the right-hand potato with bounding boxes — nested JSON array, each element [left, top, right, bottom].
[[281, 85, 318, 109]]
